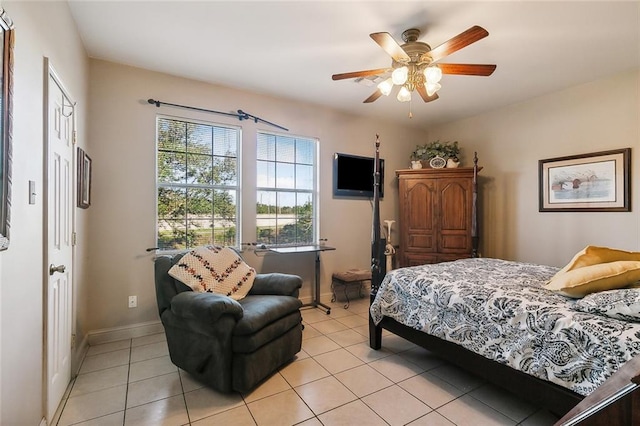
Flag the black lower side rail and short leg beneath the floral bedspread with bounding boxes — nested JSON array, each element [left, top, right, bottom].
[[369, 317, 584, 417]]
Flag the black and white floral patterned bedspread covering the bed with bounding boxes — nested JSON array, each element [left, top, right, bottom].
[[370, 258, 640, 395]]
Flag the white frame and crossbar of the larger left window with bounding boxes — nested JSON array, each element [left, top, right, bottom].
[[154, 114, 243, 254]]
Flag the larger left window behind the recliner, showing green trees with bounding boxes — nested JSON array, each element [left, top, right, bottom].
[[157, 117, 240, 250]]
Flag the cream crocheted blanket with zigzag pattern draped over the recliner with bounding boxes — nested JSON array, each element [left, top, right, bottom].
[[169, 246, 256, 300]]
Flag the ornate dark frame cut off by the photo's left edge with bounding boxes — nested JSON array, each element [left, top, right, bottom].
[[0, 7, 15, 251]]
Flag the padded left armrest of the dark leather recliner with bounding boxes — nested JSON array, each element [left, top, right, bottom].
[[171, 291, 244, 324]]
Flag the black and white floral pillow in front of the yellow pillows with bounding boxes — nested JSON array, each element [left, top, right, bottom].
[[573, 288, 640, 322]]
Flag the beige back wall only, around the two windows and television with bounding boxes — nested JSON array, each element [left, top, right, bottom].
[[82, 60, 424, 330]]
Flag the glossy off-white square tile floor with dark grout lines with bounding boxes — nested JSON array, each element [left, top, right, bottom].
[[52, 298, 557, 426]]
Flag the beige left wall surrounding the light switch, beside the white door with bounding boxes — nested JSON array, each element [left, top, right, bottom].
[[0, 1, 88, 425]]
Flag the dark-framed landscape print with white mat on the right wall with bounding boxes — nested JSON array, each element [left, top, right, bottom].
[[538, 148, 631, 212]]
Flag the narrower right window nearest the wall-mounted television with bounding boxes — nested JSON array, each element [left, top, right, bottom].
[[256, 133, 318, 245]]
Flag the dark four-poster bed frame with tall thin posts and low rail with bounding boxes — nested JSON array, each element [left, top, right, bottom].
[[369, 141, 640, 418]]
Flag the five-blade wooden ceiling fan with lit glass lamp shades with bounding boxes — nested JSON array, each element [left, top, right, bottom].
[[331, 25, 496, 103]]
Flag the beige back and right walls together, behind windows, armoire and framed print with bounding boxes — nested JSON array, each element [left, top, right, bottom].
[[81, 60, 640, 331]]
